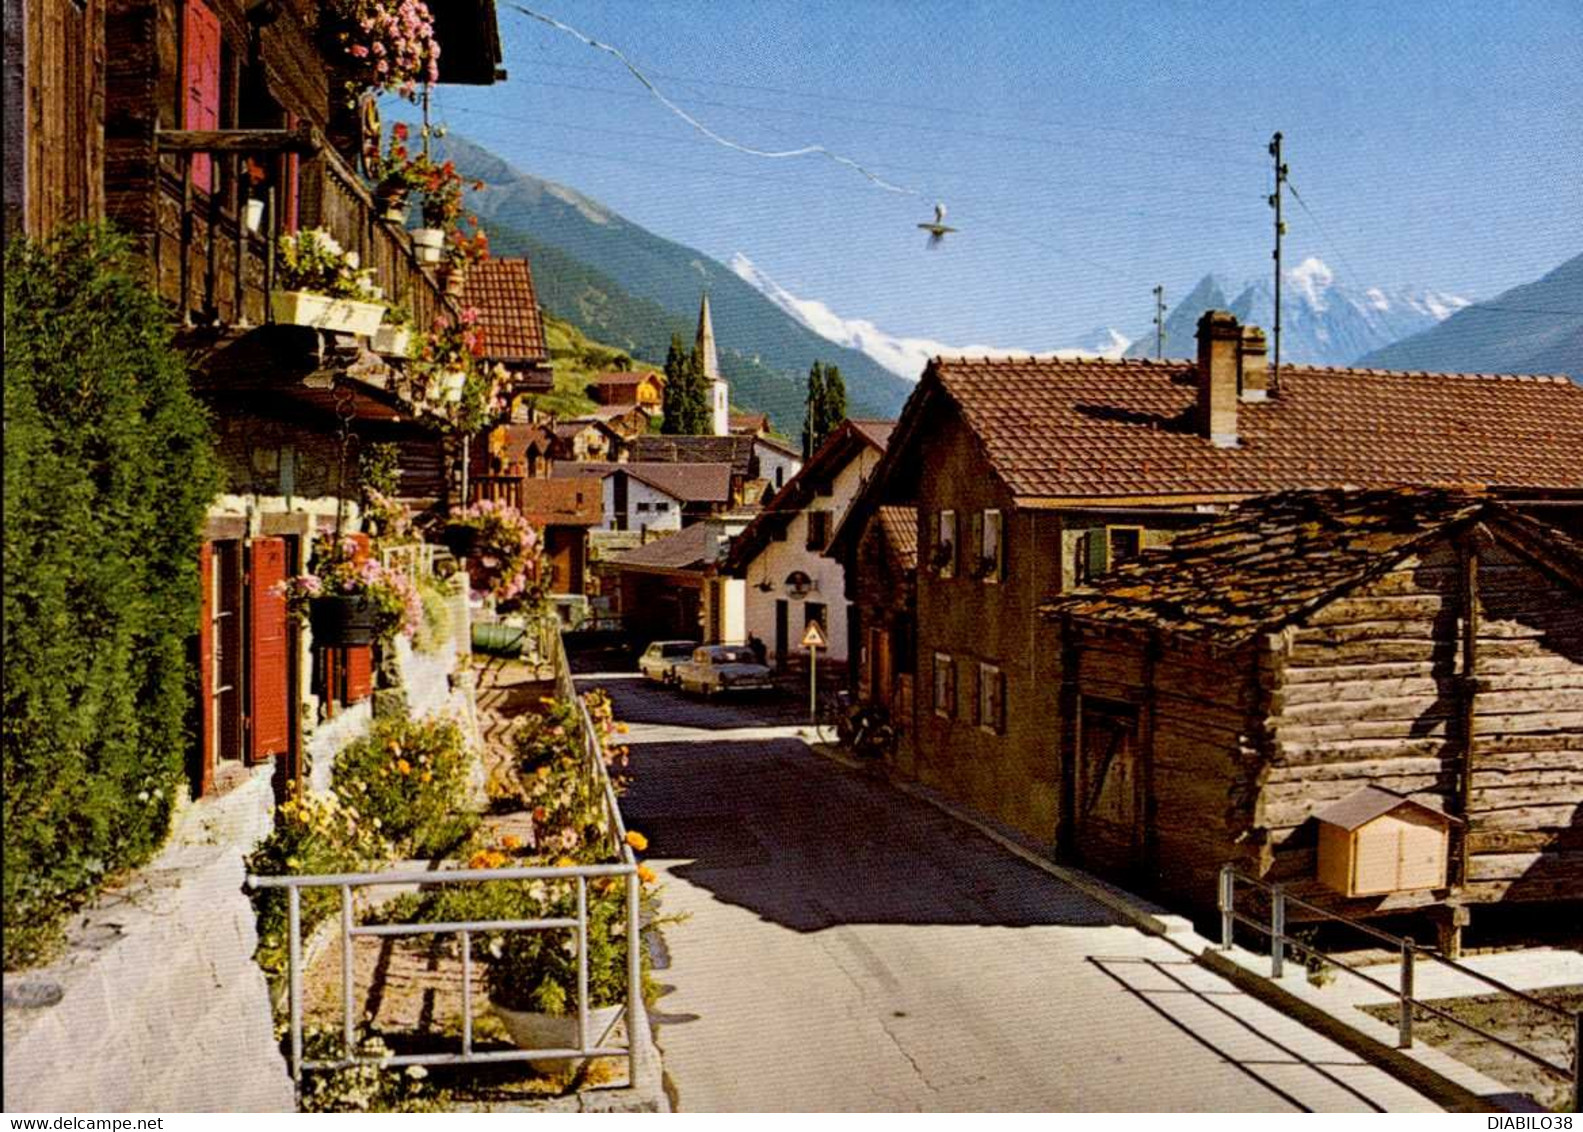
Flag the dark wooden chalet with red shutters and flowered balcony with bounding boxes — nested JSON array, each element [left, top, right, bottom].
[[5, 0, 503, 795]]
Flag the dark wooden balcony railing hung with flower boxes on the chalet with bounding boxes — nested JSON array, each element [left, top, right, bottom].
[[149, 130, 457, 329]]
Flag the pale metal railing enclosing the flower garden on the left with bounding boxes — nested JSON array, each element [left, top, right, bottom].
[[247, 636, 644, 1085]]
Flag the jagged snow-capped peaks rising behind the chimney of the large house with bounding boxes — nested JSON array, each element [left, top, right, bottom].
[[1127, 256, 1469, 366]]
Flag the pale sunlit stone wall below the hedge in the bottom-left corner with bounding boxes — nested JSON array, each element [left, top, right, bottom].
[[5, 766, 294, 1111]]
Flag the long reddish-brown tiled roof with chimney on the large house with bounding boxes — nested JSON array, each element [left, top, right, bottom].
[[924, 358, 1583, 499]]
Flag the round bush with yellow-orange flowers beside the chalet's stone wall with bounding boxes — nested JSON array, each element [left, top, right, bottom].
[[334, 719, 476, 857]]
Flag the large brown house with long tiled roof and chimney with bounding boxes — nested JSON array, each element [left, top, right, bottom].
[[831, 312, 1583, 847]]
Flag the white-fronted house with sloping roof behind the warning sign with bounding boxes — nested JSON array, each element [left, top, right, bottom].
[[711, 421, 894, 668]]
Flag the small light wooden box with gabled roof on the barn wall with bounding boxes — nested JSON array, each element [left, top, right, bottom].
[[1314, 787, 1456, 896]]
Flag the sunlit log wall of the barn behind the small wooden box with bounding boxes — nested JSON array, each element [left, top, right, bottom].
[[1255, 532, 1583, 901]]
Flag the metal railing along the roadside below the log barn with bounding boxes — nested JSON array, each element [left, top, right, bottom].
[[1217, 864, 1583, 1111]]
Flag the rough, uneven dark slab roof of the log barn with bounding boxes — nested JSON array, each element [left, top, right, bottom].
[[1042, 488, 1583, 644]]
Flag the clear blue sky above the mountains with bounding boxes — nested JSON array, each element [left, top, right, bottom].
[[421, 0, 1583, 348]]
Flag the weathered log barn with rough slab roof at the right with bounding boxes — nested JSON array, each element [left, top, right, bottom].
[[1043, 489, 1583, 947]]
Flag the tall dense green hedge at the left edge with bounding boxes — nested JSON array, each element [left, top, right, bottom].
[[3, 228, 218, 969]]
